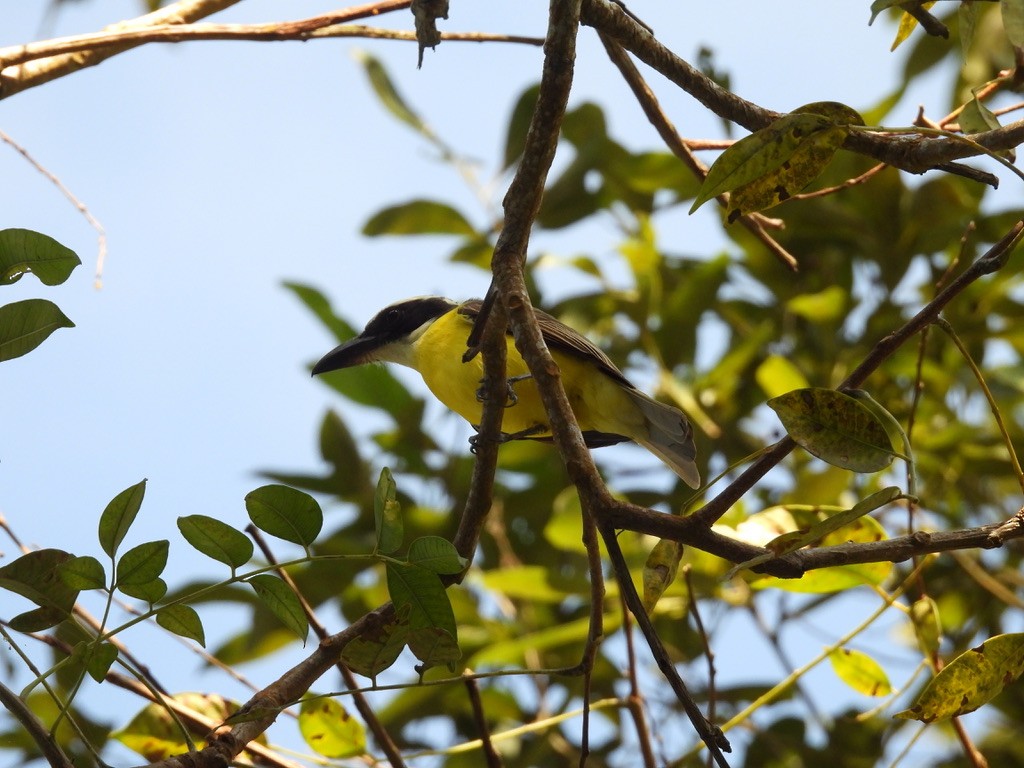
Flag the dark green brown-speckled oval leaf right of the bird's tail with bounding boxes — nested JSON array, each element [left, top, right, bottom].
[[768, 388, 895, 472]]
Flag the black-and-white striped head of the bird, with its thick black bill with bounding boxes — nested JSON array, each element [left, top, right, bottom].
[[313, 296, 458, 376]]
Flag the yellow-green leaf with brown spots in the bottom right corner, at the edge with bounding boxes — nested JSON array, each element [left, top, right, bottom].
[[894, 633, 1024, 723]]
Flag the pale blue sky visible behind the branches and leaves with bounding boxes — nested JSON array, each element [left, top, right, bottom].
[[0, 0, 958, 765]]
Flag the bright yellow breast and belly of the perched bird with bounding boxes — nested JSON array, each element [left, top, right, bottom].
[[413, 310, 647, 438]]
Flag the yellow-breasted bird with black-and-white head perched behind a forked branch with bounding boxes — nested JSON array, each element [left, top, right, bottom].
[[312, 296, 700, 488]]
